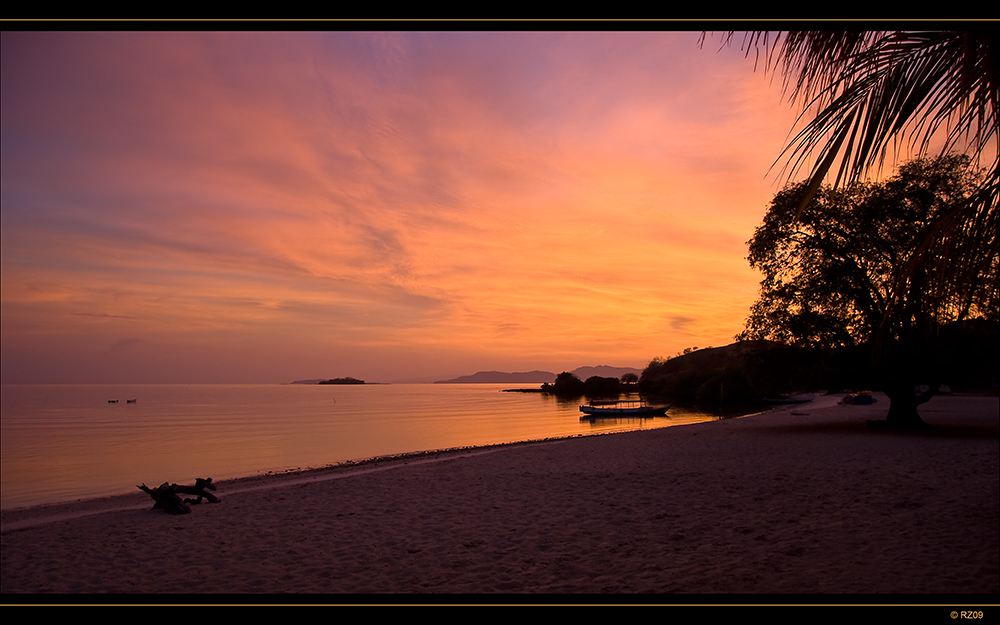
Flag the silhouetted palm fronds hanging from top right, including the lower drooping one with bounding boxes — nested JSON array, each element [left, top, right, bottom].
[[702, 30, 1000, 426]]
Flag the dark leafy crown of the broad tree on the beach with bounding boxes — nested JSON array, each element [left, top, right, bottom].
[[737, 155, 998, 347]]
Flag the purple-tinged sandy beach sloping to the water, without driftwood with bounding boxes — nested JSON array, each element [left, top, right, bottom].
[[0, 396, 1000, 602]]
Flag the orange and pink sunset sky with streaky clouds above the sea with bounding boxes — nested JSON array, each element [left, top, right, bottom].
[[0, 31, 812, 383]]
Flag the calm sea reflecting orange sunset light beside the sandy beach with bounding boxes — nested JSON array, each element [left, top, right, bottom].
[[0, 384, 714, 509]]
